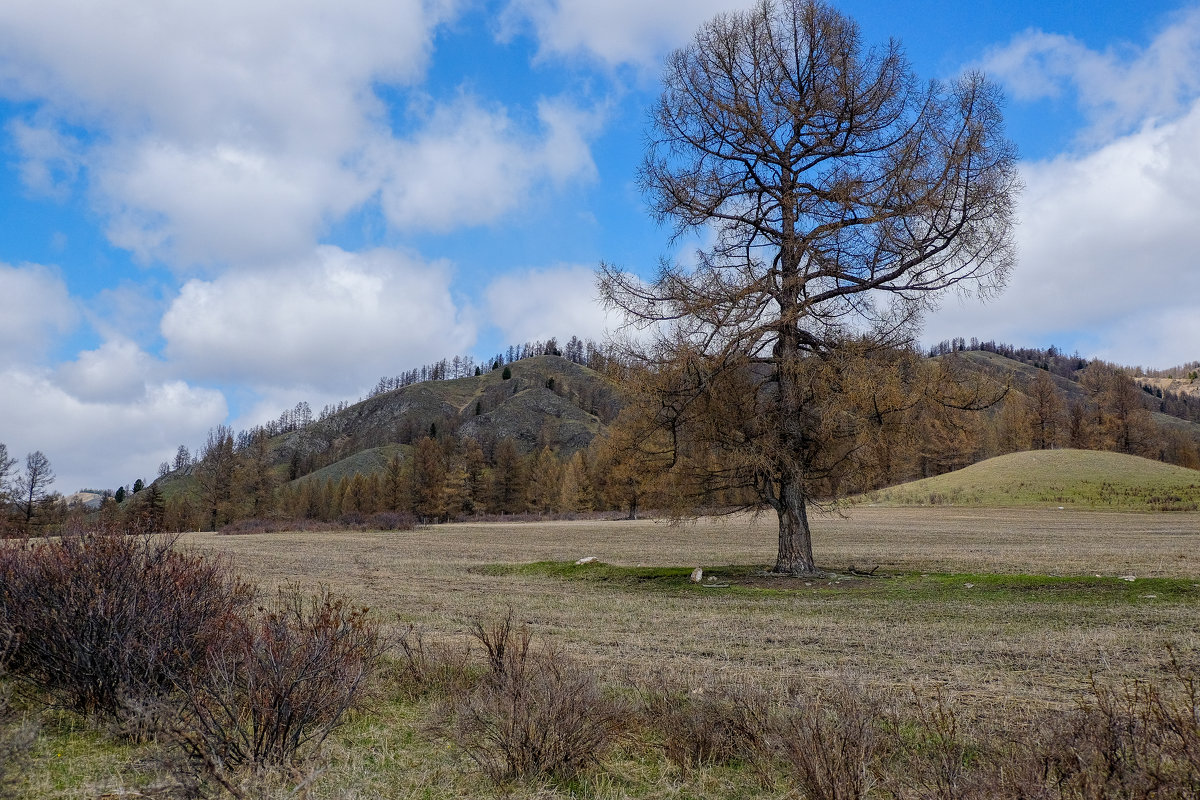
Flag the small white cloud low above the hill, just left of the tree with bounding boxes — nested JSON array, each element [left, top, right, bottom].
[[486, 265, 619, 344]]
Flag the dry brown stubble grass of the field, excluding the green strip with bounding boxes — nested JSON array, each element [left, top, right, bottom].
[[177, 507, 1200, 712]]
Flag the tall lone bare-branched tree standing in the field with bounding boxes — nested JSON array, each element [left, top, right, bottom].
[[599, 0, 1019, 575]]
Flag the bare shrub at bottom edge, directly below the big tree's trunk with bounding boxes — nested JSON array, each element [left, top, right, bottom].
[[780, 682, 886, 800]]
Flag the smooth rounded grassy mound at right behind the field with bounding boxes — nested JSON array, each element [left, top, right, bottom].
[[858, 450, 1200, 511]]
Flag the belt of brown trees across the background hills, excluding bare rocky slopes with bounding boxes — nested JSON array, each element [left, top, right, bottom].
[[0, 336, 1200, 534]]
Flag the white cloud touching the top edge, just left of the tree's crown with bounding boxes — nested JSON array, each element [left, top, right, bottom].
[[500, 0, 750, 70]]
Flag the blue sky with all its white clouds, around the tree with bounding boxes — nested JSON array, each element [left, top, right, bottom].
[[0, 0, 1200, 493]]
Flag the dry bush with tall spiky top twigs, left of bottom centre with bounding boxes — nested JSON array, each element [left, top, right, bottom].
[[440, 614, 628, 783]]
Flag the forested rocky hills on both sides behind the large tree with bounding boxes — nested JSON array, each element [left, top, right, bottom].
[[84, 343, 1200, 530]]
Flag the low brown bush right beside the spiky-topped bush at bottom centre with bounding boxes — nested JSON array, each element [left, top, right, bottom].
[[642, 676, 778, 770]]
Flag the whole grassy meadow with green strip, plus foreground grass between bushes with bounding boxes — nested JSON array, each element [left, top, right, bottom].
[[11, 506, 1200, 799]]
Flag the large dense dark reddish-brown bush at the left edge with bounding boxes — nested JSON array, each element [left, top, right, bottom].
[[0, 534, 253, 718]]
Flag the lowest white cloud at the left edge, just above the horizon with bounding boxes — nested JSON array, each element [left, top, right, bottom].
[[0, 362, 228, 494]]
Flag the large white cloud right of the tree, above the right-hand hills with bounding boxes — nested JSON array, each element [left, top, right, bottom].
[[925, 102, 1200, 366]]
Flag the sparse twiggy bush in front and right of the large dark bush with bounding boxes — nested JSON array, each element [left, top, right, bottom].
[[160, 587, 382, 788]]
